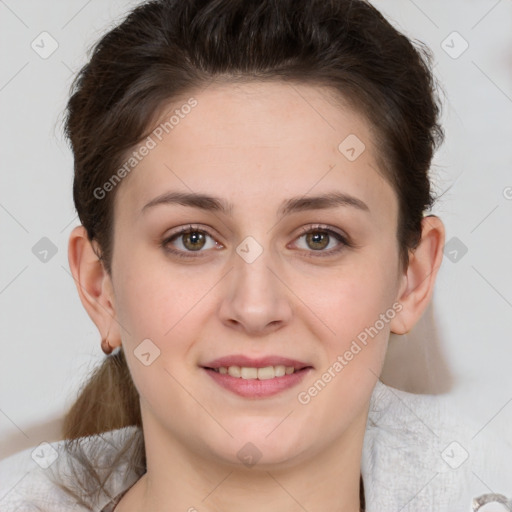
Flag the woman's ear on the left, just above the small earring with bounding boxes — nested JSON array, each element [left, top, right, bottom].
[[68, 226, 121, 349]]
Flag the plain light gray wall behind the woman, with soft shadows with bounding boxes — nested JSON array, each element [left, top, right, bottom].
[[0, 0, 512, 458]]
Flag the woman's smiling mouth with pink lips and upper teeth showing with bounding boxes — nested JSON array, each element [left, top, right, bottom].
[[202, 356, 313, 398]]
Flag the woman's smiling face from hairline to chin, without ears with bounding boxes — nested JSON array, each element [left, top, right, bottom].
[[112, 83, 401, 465]]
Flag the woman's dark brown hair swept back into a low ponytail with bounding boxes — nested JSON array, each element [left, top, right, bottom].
[[53, 0, 444, 506]]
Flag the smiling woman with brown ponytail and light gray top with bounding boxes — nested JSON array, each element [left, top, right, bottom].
[[3, 0, 506, 512]]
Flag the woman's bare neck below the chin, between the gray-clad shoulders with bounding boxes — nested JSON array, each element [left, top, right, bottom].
[[115, 415, 366, 512]]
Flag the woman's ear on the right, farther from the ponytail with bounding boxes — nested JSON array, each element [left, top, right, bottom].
[[390, 215, 445, 334]]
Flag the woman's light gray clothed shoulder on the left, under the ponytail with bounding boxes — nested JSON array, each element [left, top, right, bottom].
[[0, 427, 140, 512]]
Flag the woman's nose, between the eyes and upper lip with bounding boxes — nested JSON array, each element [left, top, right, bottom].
[[219, 243, 293, 337]]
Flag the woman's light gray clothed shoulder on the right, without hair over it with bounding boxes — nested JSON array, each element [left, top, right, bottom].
[[361, 381, 512, 512]]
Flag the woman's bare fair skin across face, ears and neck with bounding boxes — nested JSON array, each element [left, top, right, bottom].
[[69, 82, 445, 512]]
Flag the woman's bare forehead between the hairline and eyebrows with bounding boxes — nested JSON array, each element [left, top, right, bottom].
[[116, 82, 397, 224]]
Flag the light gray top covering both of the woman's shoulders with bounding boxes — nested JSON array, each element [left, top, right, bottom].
[[0, 381, 512, 512]]
